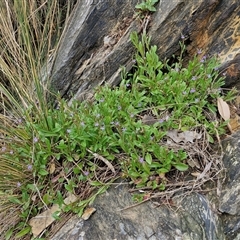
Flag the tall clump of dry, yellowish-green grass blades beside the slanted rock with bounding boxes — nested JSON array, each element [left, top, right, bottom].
[[0, 0, 74, 238]]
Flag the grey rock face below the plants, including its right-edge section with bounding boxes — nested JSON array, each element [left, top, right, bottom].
[[49, 132, 240, 240]]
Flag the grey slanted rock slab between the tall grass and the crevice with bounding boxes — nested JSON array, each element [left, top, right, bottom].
[[49, 0, 138, 99]]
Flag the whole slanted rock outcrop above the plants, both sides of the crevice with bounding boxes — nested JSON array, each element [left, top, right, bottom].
[[47, 0, 240, 99]]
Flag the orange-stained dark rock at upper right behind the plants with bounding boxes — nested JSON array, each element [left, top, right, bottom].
[[149, 0, 240, 88]]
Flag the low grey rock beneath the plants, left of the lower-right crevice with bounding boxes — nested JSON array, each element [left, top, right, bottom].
[[52, 181, 225, 240]]
